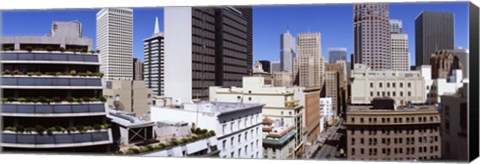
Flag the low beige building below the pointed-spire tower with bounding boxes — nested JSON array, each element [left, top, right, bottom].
[[103, 80, 152, 119]]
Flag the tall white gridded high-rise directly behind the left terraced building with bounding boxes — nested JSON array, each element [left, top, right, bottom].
[[97, 8, 133, 80]]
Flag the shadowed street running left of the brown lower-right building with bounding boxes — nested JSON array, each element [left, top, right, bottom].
[[313, 119, 345, 159]]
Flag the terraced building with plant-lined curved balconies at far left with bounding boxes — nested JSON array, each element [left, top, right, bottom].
[[0, 22, 113, 153]]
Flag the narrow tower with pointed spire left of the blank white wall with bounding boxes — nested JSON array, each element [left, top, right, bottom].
[[143, 18, 165, 96]]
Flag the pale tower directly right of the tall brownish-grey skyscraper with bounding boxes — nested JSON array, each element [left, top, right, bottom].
[[390, 19, 410, 71]]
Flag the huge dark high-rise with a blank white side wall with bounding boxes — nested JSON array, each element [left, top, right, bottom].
[[164, 7, 252, 101]]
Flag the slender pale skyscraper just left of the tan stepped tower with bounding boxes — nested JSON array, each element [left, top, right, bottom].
[[280, 29, 296, 72]]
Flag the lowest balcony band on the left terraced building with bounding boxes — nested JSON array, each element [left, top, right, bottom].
[[2, 129, 112, 148]]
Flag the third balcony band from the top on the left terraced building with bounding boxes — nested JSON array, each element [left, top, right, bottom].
[[1, 102, 106, 117]]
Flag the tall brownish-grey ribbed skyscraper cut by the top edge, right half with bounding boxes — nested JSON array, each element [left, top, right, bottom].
[[353, 3, 391, 70]]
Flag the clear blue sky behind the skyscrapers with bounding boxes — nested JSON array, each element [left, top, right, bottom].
[[2, 2, 468, 64]]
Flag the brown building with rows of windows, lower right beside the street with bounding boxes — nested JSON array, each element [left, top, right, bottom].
[[345, 106, 442, 160]]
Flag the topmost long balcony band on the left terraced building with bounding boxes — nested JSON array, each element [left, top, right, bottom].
[[1, 52, 99, 65]]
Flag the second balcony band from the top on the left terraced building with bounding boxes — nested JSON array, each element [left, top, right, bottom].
[[2, 76, 102, 89]]
